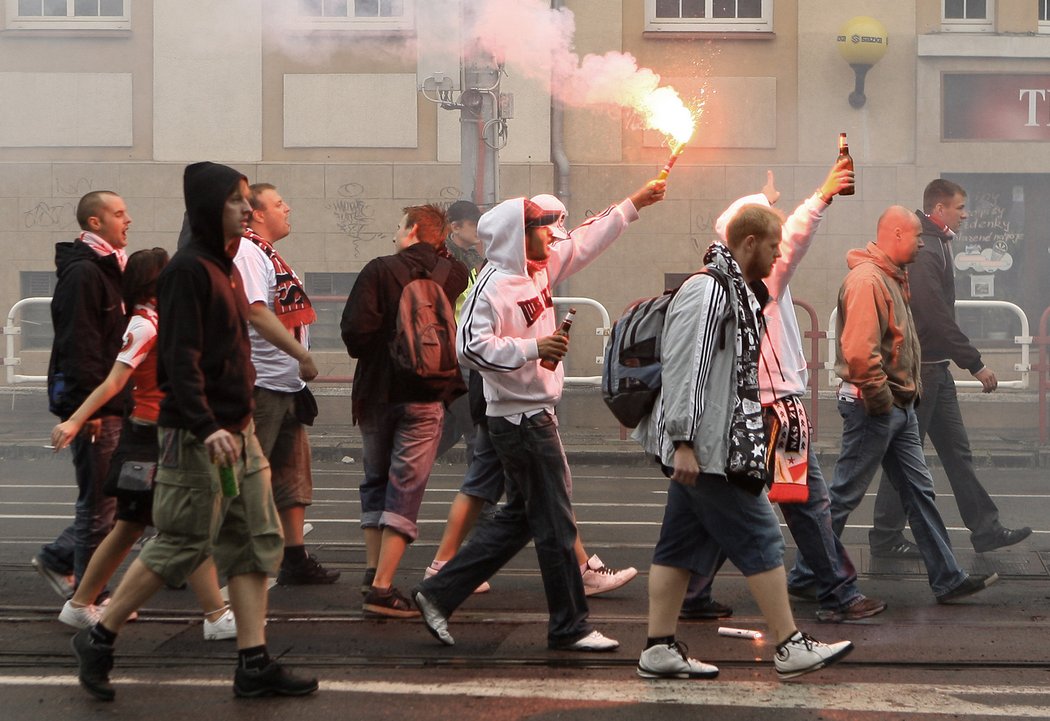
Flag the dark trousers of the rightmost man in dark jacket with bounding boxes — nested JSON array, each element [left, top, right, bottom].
[[868, 361, 1002, 549]]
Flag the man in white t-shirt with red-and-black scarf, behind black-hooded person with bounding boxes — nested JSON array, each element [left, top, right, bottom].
[[233, 183, 339, 586]]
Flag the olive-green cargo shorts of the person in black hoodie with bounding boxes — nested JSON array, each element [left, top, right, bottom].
[[139, 423, 285, 586]]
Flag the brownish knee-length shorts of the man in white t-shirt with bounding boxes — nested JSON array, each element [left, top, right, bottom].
[[254, 386, 314, 511]]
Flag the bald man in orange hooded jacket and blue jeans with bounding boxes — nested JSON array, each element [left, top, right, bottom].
[[792, 206, 999, 603]]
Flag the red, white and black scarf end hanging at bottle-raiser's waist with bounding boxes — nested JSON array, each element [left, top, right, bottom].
[[765, 396, 810, 503]]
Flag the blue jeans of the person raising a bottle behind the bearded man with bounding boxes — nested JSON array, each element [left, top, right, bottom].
[[684, 444, 861, 609]]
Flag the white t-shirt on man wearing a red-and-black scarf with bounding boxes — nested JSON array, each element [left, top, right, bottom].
[[233, 238, 310, 393]]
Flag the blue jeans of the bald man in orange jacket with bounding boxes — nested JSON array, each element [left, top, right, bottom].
[[789, 398, 966, 596]]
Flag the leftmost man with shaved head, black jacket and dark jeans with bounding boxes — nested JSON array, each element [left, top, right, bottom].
[[33, 190, 131, 599]]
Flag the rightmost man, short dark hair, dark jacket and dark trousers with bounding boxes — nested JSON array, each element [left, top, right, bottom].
[[868, 178, 1032, 558]]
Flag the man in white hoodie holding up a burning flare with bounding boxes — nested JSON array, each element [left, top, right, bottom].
[[413, 181, 666, 651]]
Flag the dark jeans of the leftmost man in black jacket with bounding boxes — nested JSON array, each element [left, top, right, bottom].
[[41, 416, 123, 585]]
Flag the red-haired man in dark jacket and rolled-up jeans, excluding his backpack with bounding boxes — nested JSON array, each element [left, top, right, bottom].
[[339, 205, 467, 618]]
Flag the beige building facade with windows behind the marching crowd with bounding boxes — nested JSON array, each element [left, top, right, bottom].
[[0, 0, 1050, 388]]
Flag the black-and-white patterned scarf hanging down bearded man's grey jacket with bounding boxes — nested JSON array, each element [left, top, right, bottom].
[[704, 242, 772, 495]]
